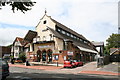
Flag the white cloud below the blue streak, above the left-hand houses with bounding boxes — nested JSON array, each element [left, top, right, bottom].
[[0, 27, 28, 46]]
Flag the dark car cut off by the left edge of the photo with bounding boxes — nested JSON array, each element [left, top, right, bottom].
[[0, 58, 9, 80]]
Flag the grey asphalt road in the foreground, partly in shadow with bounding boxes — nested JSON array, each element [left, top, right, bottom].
[[7, 67, 119, 80]]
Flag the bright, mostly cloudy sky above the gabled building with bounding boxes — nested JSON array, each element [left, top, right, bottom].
[[0, 0, 119, 46]]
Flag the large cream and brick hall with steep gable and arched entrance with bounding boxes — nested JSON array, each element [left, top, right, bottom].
[[24, 13, 98, 63]]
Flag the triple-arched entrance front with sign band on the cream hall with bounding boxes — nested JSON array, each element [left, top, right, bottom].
[[35, 43, 54, 63]]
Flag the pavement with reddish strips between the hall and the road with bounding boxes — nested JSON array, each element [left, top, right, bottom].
[[9, 61, 120, 76]]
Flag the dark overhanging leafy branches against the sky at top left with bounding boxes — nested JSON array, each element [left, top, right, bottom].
[[0, 0, 36, 13]]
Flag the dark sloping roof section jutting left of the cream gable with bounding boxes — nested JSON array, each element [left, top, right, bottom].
[[24, 30, 37, 42]]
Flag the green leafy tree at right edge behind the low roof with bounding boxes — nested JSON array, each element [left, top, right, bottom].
[[106, 34, 120, 50]]
